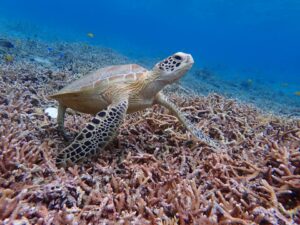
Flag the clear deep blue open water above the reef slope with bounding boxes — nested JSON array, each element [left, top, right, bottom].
[[0, 0, 300, 114]]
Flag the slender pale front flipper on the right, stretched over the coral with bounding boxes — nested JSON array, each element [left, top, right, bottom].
[[154, 93, 220, 148]]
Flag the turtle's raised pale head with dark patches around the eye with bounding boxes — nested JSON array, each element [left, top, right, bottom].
[[153, 52, 194, 84]]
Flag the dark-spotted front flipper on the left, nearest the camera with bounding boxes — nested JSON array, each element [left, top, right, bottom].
[[56, 99, 128, 167]]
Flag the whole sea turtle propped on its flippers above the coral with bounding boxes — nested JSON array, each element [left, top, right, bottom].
[[50, 52, 215, 167]]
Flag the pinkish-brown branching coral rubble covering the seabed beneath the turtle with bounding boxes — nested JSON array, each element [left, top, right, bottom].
[[0, 59, 300, 225]]
